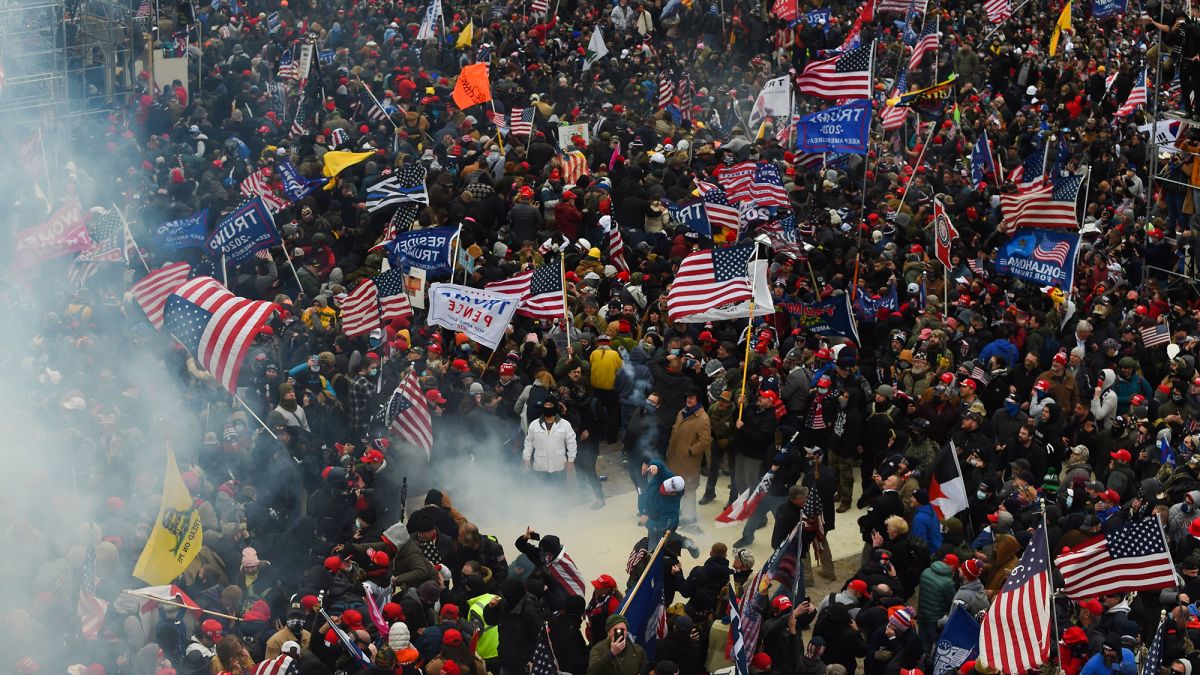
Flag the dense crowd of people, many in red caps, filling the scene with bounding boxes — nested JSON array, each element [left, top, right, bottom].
[[7, 0, 1200, 675]]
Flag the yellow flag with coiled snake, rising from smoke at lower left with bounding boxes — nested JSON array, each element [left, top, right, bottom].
[[133, 449, 204, 586]]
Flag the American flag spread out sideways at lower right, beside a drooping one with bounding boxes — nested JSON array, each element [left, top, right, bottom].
[[1055, 518, 1176, 598]]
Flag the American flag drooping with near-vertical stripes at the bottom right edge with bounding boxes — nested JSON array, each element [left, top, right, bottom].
[[979, 524, 1051, 673]]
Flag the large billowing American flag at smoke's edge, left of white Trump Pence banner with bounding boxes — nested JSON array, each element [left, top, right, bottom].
[[163, 276, 276, 393]]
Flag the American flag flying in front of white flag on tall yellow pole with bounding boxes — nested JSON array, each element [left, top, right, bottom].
[[667, 244, 755, 321]]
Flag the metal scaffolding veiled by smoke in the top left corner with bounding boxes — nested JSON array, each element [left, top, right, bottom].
[[0, 0, 137, 129]]
